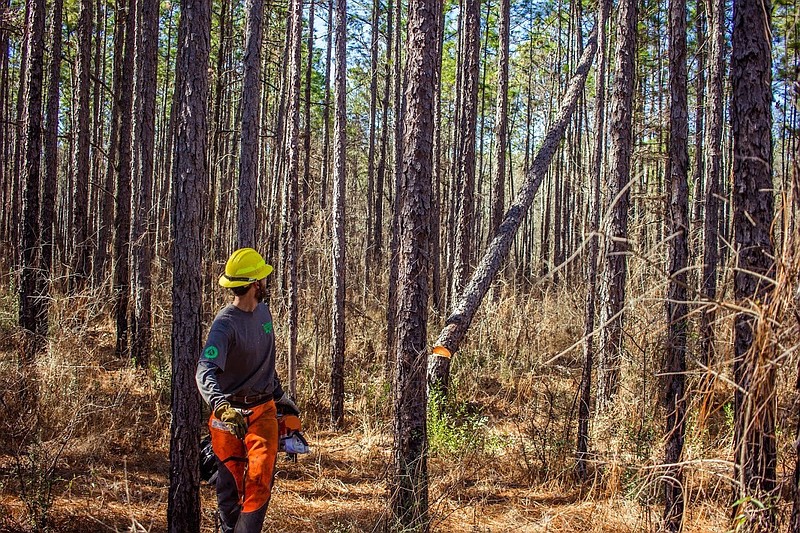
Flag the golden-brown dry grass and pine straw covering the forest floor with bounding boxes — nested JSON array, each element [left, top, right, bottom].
[[0, 272, 795, 532]]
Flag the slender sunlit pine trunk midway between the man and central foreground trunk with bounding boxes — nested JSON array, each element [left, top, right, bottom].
[[331, 0, 347, 428]]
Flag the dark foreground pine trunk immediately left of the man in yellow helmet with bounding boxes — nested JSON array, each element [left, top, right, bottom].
[[167, 0, 211, 533]]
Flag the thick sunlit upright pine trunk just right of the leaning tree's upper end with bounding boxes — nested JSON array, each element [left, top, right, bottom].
[[597, 0, 637, 411]]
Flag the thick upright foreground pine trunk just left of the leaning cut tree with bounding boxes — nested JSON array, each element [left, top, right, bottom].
[[389, 0, 442, 533]]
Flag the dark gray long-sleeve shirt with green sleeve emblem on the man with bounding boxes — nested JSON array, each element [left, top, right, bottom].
[[195, 303, 283, 411]]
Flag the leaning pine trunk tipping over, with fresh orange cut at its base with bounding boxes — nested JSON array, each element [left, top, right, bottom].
[[428, 30, 597, 364]]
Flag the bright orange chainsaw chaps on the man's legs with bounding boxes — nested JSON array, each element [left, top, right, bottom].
[[208, 401, 278, 513]]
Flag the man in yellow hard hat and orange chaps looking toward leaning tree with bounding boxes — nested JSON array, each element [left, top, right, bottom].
[[196, 248, 299, 533]]
